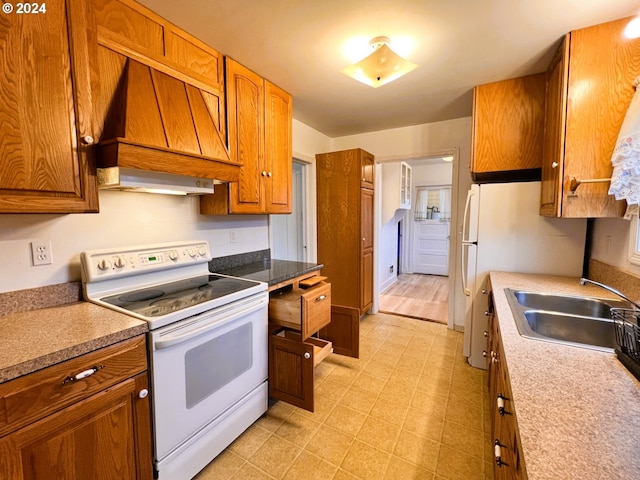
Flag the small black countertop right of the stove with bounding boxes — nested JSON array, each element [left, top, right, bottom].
[[214, 259, 324, 286]]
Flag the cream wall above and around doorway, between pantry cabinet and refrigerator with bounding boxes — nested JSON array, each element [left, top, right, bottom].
[[331, 117, 471, 329]]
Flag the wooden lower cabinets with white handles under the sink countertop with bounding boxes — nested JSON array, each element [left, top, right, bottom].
[[487, 295, 527, 480]]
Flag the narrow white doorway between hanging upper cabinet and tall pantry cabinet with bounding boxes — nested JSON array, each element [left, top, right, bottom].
[[269, 159, 308, 262]]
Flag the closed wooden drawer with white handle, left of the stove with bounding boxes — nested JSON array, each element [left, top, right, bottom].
[[0, 335, 147, 436]]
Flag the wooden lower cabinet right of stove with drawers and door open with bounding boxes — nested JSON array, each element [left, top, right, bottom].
[[269, 279, 360, 412]]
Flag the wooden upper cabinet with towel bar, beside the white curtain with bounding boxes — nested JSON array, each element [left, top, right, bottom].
[[540, 18, 640, 218]]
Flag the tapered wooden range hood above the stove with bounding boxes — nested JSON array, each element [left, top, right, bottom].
[[98, 59, 240, 193]]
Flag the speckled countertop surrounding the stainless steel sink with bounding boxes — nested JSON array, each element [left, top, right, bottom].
[[490, 272, 640, 480]]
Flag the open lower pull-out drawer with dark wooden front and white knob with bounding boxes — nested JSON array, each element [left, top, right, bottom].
[[269, 328, 332, 412]]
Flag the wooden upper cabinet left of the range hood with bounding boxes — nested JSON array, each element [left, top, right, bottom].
[[0, 0, 98, 213]]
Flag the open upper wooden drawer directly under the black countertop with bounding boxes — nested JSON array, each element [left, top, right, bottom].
[[269, 282, 331, 340]]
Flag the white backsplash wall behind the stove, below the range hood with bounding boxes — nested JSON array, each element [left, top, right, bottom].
[[0, 191, 269, 292]]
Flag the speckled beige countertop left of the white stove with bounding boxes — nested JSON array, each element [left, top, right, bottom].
[[0, 301, 147, 383]]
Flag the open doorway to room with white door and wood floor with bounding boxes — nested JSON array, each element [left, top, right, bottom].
[[377, 156, 457, 323]]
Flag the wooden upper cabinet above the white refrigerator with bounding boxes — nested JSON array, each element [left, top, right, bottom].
[[470, 73, 545, 182]]
